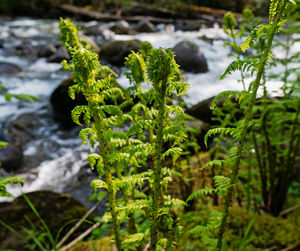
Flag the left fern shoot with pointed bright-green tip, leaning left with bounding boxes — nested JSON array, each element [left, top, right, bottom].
[[60, 19, 122, 250]]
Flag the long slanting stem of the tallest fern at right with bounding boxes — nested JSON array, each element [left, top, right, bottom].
[[217, 0, 286, 251]]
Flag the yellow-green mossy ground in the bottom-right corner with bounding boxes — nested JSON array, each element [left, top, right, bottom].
[[178, 206, 300, 251]]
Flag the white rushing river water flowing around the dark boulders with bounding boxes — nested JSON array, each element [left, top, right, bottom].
[[0, 18, 299, 206]]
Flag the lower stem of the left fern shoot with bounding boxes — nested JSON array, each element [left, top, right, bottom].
[[90, 106, 121, 251]]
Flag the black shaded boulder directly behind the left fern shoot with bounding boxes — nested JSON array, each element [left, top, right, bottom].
[[50, 79, 87, 129]]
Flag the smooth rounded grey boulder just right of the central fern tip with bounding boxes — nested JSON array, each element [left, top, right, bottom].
[[173, 41, 208, 73]]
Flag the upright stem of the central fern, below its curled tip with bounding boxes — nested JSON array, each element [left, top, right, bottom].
[[150, 81, 167, 251]]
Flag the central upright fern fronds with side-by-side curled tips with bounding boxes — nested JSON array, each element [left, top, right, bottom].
[[126, 43, 188, 250]]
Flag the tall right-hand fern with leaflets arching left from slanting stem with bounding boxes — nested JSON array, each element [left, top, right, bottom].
[[189, 0, 297, 250]]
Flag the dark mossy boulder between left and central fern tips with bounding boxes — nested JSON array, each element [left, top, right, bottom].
[[99, 40, 142, 66]]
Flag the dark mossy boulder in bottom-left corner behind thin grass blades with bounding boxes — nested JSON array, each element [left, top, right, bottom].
[[0, 191, 94, 251]]
